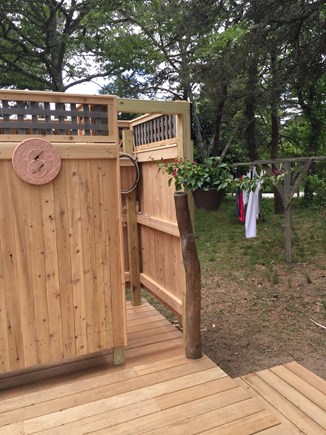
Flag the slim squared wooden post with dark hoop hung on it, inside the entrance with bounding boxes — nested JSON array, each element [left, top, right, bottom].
[[122, 130, 141, 306]]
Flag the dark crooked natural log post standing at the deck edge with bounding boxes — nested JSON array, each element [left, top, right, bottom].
[[174, 192, 202, 359]]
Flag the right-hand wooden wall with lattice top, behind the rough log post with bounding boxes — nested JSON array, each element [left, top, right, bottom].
[[118, 100, 192, 323]]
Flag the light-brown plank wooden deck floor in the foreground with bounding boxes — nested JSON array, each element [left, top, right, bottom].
[[0, 303, 326, 435]]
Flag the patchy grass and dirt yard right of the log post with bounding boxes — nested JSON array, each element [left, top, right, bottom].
[[196, 199, 326, 379]]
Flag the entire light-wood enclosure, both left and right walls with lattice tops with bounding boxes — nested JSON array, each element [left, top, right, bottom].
[[0, 90, 192, 373]]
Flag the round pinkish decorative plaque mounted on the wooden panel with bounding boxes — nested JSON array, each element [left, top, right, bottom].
[[12, 138, 61, 184]]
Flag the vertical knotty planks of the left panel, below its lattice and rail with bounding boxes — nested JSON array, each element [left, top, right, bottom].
[[0, 158, 126, 373]]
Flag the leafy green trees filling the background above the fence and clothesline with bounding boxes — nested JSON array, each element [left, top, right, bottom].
[[0, 0, 326, 169]]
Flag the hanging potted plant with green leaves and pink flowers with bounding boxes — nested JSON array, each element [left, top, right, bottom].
[[159, 157, 233, 211]]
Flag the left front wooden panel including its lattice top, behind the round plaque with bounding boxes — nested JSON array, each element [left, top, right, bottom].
[[0, 91, 126, 373]]
